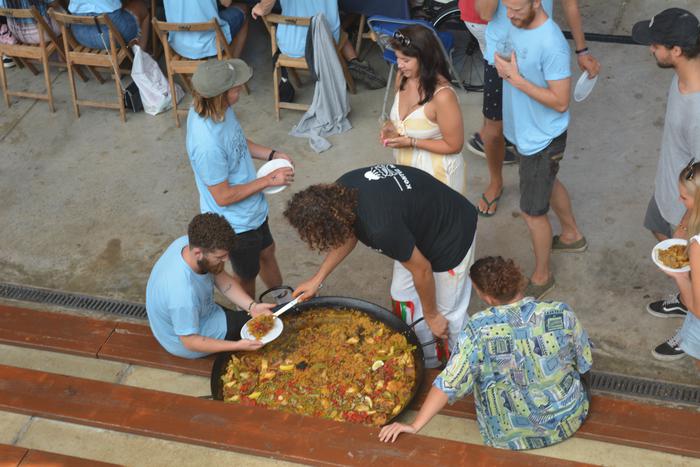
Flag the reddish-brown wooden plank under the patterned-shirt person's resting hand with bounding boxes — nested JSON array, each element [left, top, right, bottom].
[[0, 365, 588, 467]]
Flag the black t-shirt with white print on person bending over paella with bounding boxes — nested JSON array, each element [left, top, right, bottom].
[[338, 164, 477, 272]]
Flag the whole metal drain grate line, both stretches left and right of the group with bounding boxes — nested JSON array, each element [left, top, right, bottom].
[[0, 282, 700, 406]]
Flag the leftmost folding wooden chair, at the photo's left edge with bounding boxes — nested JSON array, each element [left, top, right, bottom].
[[0, 7, 86, 112]]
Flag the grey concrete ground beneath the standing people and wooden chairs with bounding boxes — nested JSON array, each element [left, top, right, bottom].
[[0, 0, 700, 465]]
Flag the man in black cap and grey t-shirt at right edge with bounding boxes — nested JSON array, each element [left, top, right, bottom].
[[632, 8, 700, 361]]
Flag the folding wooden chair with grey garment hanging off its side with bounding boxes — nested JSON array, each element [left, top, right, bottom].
[[263, 13, 355, 120]]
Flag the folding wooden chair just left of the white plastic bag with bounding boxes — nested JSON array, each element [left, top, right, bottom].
[[49, 9, 134, 122]]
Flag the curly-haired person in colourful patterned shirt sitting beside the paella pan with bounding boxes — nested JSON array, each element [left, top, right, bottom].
[[379, 257, 592, 450]]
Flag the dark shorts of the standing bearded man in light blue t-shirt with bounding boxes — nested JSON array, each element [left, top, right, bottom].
[[518, 131, 566, 216]]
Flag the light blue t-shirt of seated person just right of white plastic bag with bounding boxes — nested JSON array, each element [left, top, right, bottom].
[[163, 0, 231, 58]]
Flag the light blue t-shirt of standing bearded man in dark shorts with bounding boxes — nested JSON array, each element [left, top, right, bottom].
[[503, 18, 571, 156]]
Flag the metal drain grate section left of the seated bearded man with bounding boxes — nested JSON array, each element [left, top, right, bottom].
[[0, 283, 146, 318]]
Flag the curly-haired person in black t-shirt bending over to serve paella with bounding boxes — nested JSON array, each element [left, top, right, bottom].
[[284, 165, 477, 367]]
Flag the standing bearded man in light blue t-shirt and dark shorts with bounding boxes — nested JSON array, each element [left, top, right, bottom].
[[494, 0, 588, 298]]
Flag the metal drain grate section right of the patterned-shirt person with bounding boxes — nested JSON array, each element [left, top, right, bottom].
[[591, 371, 700, 406]]
